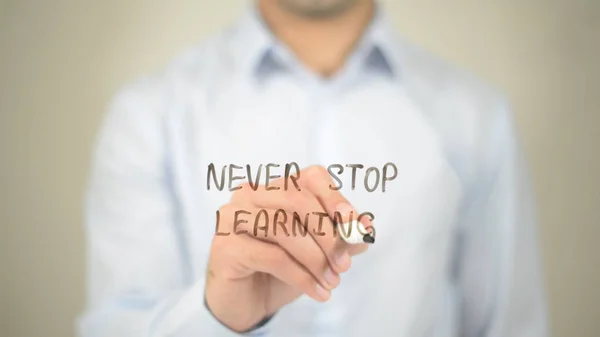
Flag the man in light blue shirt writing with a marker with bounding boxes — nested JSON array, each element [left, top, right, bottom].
[[80, 0, 547, 337]]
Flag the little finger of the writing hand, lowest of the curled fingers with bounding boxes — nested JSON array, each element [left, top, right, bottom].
[[239, 236, 331, 302]]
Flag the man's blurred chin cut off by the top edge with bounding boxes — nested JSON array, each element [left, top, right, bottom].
[[278, 0, 358, 18]]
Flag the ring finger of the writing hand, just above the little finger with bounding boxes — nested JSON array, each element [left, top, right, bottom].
[[221, 205, 340, 289]]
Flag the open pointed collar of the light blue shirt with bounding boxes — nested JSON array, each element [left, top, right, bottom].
[[232, 4, 399, 77]]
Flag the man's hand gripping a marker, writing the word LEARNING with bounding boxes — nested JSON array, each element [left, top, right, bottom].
[[206, 166, 371, 332]]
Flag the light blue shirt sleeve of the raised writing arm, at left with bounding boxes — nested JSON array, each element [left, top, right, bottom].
[[78, 80, 274, 337]]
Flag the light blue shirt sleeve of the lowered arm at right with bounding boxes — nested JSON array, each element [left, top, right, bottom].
[[457, 103, 548, 337]]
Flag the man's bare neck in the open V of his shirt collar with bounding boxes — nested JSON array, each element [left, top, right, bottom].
[[258, 0, 375, 77]]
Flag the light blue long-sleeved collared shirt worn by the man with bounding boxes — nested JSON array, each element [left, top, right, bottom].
[[78, 5, 547, 337]]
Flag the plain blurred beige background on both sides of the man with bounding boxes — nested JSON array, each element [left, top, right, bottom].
[[0, 0, 600, 337]]
